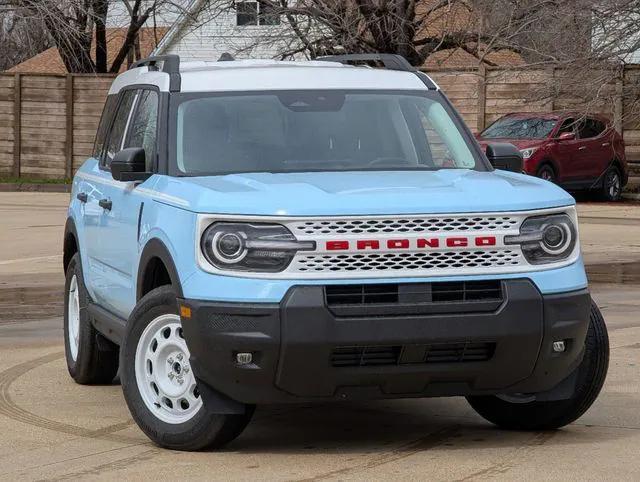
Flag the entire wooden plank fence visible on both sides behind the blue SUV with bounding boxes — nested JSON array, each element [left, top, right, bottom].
[[0, 66, 640, 178]]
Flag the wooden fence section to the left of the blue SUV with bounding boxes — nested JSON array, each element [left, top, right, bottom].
[[0, 73, 114, 178]]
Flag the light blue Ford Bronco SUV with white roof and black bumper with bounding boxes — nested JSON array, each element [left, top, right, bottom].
[[64, 55, 609, 450]]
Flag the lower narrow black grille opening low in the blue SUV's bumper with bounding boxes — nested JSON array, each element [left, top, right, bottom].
[[331, 342, 496, 367]]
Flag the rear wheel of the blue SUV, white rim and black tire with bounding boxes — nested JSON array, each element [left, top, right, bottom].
[[64, 253, 118, 385]]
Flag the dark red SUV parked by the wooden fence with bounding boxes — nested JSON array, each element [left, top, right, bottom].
[[476, 112, 629, 201]]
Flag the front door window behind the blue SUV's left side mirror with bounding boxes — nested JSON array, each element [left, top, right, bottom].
[[125, 90, 158, 171]]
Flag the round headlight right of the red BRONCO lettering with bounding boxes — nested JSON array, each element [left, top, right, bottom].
[[504, 214, 578, 264]]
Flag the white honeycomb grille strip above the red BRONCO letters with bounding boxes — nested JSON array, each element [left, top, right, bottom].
[[288, 215, 519, 235]]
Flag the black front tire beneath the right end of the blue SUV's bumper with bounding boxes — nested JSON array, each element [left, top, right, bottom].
[[467, 301, 609, 430]]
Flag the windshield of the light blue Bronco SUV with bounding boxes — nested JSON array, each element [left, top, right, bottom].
[[170, 91, 486, 176]]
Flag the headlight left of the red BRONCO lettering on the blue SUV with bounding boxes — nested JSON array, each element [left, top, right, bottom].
[[200, 222, 315, 273]]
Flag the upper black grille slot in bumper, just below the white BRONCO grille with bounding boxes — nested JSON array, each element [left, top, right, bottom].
[[325, 280, 502, 307]]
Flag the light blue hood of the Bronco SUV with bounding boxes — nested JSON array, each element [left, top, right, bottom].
[[150, 169, 574, 216]]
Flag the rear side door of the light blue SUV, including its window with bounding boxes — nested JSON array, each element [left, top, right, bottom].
[[85, 90, 136, 314]]
